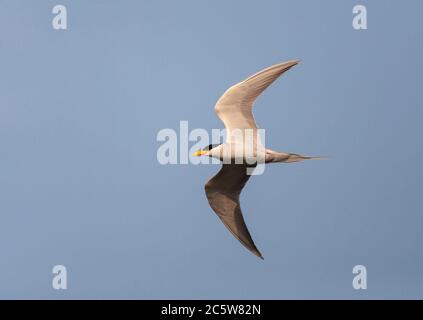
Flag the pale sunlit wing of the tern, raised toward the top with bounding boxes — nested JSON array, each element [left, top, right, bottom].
[[215, 60, 299, 144]]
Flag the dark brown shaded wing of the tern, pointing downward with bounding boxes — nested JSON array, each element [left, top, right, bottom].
[[205, 164, 263, 259]]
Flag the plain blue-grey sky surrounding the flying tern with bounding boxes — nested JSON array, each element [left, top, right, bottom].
[[0, 0, 423, 299]]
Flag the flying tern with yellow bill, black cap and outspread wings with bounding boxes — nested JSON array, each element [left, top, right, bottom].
[[193, 60, 324, 259]]
